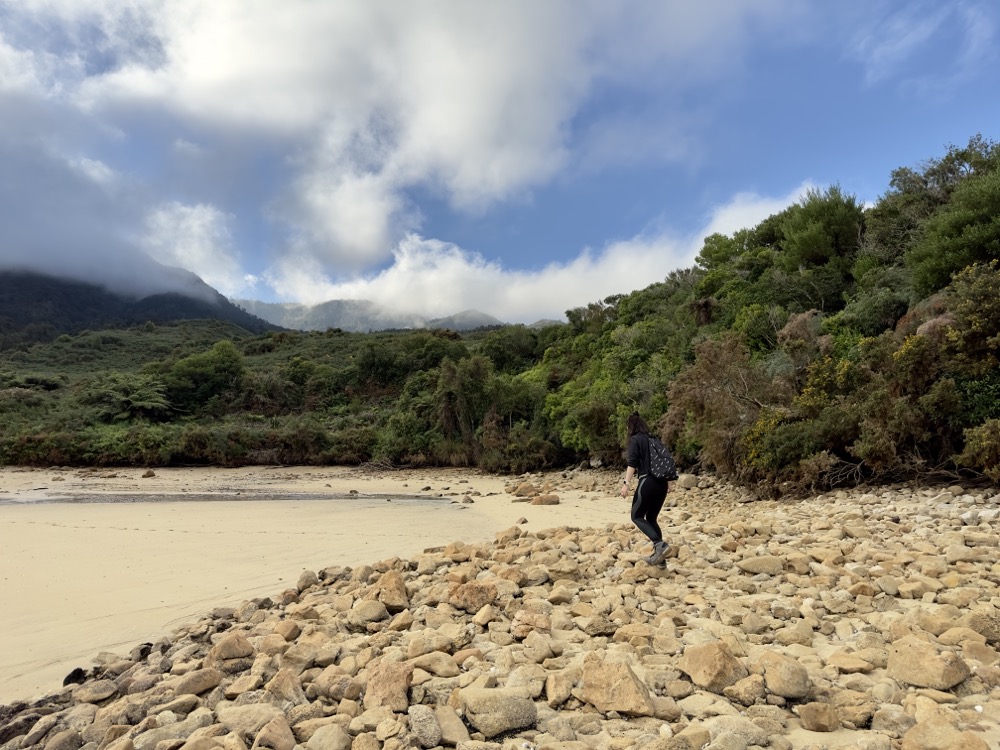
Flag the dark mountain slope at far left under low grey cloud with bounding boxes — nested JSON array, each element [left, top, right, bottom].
[[0, 269, 276, 345]]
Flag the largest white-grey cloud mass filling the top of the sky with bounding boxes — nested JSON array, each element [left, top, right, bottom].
[[0, 0, 796, 271]]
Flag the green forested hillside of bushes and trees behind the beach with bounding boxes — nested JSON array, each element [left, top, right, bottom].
[[0, 136, 1000, 492]]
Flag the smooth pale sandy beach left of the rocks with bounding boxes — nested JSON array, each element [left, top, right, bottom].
[[0, 467, 628, 704]]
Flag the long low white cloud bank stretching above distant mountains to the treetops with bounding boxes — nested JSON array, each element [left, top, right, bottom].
[[267, 183, 811, 323]]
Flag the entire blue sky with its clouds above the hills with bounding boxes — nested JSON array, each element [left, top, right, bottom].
[[0, 0, 1000, 323]]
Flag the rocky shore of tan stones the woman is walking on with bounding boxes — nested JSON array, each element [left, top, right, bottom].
[[0, 471, 1000, 750]]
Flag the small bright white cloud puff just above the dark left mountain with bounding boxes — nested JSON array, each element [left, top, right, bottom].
[[143, 202, 251, 296]]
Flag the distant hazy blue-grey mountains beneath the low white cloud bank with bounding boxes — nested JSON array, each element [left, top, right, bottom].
[[233, 299, 503, 333]]
